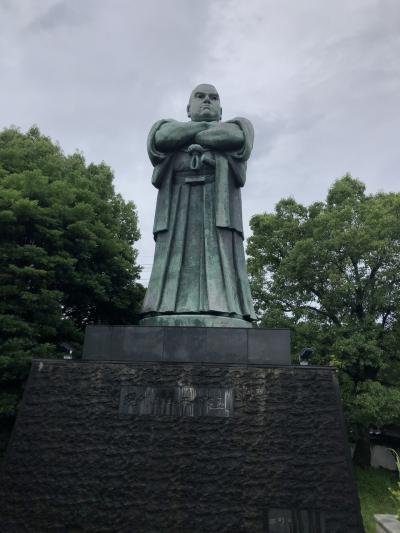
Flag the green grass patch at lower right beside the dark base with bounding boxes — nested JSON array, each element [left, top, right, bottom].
[[354, 466, 398, 533]]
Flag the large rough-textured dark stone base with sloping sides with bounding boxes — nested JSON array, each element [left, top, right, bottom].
[[0, 324, 363, 533]]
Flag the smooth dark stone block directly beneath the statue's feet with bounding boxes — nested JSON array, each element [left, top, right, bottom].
[[83, 326, 290, 365]]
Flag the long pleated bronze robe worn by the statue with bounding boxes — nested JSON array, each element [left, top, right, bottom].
[[142, 118, 255, 321]]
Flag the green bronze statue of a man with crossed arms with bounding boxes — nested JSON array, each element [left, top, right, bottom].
[[140, 84, 256, 327]]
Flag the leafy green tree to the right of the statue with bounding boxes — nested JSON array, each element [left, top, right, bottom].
[[247, 175, 400, 464]]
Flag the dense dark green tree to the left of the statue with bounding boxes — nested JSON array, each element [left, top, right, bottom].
[[0, 127, 143, 444]]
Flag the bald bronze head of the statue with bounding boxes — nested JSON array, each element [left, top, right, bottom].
[[187, 83, 222, 122]]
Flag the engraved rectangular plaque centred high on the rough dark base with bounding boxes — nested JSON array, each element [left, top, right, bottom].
[[119, 385, 233, 418]]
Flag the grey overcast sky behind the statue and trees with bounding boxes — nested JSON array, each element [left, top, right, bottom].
[[0, 0, 400, 282]]
